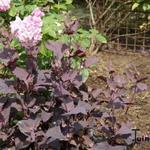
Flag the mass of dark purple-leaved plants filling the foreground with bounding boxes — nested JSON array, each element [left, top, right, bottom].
[[0, 19, 147, 150]]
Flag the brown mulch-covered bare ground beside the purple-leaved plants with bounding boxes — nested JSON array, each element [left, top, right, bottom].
[[88, 52, 150, 150]]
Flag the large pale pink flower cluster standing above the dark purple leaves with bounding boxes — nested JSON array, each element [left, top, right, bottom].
[[10, 8, 44, 49]]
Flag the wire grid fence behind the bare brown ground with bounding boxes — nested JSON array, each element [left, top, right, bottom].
[[110, 12, 150, 52]]
